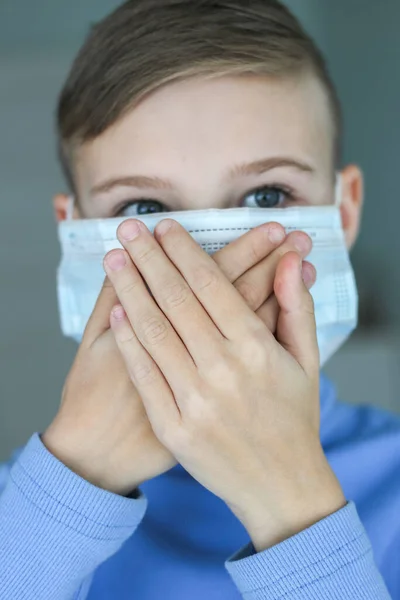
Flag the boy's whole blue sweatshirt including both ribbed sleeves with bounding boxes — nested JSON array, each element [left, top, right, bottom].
[[0, 377, 400, 600]]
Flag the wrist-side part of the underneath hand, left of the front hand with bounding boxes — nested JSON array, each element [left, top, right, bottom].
[[42, 278, 176, 495]]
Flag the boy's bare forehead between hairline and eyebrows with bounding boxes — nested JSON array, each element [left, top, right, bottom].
[[75, 75, 333, 188]]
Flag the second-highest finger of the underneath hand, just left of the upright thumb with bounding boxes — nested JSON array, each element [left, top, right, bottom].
[[234, 231, 312, 311]]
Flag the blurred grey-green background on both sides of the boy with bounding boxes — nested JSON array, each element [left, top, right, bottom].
[[0, 0, 400, 461]]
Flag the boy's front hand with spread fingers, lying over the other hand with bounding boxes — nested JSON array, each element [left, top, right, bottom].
[[104, 219, 345, 549]]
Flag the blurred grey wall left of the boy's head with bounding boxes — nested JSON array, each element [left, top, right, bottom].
[[0, 0, 121, 460]]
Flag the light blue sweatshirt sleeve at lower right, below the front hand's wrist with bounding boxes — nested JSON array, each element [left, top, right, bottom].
[[225, 502, 397, 600]]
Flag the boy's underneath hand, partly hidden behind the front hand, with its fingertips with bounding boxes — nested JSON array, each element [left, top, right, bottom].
[[42, 224, 315, 494]]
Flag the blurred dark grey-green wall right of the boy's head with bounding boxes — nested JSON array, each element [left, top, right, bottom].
[[324, 0, 400, 329]]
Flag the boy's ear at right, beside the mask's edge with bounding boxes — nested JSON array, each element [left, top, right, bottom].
[[340, 165, 364, 250]]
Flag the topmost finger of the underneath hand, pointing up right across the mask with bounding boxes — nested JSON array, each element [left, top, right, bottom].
[[212, 223, 286, 283]]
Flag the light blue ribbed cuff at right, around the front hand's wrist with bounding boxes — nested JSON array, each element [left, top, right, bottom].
[[225, 502, 378, 599]]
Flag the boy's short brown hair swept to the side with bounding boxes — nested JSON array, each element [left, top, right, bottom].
[[57, 0, 342, 188]]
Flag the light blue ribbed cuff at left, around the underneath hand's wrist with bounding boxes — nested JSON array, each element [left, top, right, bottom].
[[10, 433, 147, 540]]
